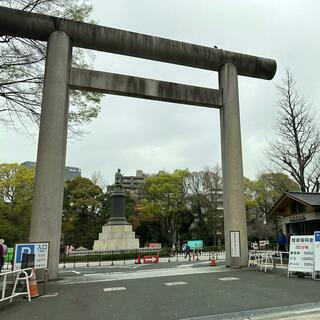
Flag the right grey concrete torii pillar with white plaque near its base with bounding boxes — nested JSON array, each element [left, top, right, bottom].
[[219, 63, 248, 267]]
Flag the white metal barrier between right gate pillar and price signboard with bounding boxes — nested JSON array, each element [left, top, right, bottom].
[[248, 250, 289, 272]]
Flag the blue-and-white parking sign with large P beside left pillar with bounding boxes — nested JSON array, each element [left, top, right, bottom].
[[13, 242, 49, 270]]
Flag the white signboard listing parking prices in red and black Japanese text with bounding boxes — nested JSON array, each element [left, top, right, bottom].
[[288, 236, 314, 273]]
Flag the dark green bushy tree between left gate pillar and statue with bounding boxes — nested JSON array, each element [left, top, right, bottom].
[[62, 177, 110, 248]]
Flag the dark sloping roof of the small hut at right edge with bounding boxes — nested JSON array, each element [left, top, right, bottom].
[[269, 192, 320, 214]]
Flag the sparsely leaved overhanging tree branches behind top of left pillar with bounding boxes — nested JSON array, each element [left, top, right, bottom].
[[0, 0, 101, 134]]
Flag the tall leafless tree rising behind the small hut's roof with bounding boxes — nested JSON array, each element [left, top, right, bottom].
[[266, 70, 320, 192]]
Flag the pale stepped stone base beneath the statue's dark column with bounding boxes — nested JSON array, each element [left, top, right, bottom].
[[93, 224, 139, 251]]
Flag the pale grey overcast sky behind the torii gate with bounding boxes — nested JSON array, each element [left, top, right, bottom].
[[0, 0, 320, 184]]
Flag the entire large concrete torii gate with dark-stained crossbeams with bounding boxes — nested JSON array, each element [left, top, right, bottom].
[[0, 7, 276, 279]]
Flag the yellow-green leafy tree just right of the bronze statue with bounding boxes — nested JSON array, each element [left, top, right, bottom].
[[142, 170, 191, 244]]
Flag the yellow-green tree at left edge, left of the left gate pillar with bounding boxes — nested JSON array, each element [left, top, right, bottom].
[[0, 163, 34, 246]]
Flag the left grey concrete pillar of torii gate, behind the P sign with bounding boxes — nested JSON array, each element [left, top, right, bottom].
[[30, 31, 72, 279]]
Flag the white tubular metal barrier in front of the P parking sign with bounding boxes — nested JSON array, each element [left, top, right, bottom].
[[0, 268, 32, 303]]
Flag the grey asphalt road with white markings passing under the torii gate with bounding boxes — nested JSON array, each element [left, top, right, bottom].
[[0, 262, 320, 320]]
